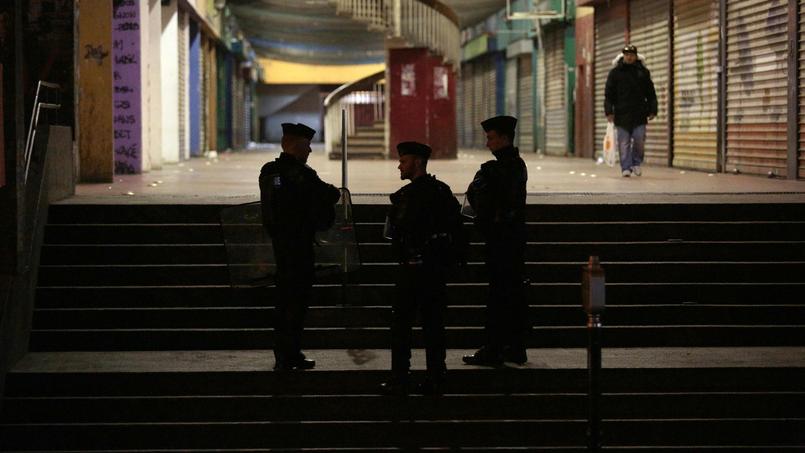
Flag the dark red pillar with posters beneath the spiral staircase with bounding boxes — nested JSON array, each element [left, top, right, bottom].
[[387, 48, 458, 159]]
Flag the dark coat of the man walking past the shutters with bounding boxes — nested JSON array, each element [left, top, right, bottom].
[[604, 58, 657, 131]]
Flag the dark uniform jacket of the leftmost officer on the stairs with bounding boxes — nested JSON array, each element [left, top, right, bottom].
[[260, 153, 341, 241]]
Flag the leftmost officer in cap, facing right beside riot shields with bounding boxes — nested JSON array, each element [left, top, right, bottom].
[[260, 123, 341, 370]]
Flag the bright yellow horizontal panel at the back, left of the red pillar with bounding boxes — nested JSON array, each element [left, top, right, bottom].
[[260, 59, 386, 85]]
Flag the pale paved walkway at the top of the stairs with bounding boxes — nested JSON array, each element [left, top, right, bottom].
[[59, 145, 805, 204]]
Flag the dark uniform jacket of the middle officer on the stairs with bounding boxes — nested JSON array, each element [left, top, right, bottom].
[[388, 175, 465, 264]]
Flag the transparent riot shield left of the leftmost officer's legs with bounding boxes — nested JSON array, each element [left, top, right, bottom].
[[221, 201, 277, 288]]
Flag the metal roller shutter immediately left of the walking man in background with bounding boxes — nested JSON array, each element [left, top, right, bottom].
[[594, 8, 626, 160]]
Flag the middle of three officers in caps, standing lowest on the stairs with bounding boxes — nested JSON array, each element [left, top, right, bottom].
[[382, 142, 465, 395]]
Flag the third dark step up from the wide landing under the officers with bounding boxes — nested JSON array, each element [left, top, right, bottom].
[[36, 282, 805, 309]]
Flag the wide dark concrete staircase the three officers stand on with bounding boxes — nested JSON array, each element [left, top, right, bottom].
[[0, 204, 805, 452]]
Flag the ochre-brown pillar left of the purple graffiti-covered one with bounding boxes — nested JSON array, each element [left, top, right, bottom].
[[76, 0, 114, 182]]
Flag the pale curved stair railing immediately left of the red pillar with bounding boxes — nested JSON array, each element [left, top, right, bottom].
[[324, 70, 386, 156]]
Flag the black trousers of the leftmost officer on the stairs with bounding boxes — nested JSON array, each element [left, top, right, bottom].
[[272, 238, 313, 362]]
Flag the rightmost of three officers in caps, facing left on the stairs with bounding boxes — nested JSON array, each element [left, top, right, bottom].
[[464, 116, 528, 366]]
